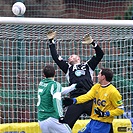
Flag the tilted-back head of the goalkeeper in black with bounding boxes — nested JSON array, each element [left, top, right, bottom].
[[68, 54, 80, 65]]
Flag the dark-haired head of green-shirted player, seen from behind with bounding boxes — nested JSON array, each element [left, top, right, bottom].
[[43, 65, 55, 78]]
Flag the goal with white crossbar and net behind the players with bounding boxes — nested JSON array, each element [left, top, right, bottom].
[[0, 18, 133, 123]]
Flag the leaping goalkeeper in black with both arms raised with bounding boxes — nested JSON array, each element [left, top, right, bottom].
[[47, 31, 104, 128]]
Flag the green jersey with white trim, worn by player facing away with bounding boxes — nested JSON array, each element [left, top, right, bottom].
[[37, 78, 63, 121]]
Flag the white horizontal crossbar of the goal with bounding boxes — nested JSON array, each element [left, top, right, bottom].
[[0, 17, 133, 27]]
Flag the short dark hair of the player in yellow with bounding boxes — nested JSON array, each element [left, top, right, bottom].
[[101, 68, 113, 82]]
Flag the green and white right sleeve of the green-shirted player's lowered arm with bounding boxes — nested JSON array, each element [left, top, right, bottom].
[[51, 82, 63, 117]]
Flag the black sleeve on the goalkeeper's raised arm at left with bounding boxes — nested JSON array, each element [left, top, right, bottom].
[[49, 44, 69, 74]]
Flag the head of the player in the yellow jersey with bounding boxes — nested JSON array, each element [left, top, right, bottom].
[[98, 68, 113, 83]]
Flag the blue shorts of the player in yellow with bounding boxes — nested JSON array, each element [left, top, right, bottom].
[[78, 120, 111, 133]]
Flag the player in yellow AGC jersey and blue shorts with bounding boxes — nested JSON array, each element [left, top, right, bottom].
[[64, 68, 124, 133]]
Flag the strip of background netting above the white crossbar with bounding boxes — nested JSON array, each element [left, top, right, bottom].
[[0, 0, 133, 19]]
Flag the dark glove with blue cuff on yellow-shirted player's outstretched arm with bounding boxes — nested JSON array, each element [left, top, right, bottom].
[[63, 97, 77, 107]]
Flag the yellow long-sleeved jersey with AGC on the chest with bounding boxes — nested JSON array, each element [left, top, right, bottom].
[[76, 83, 124, 123]]
